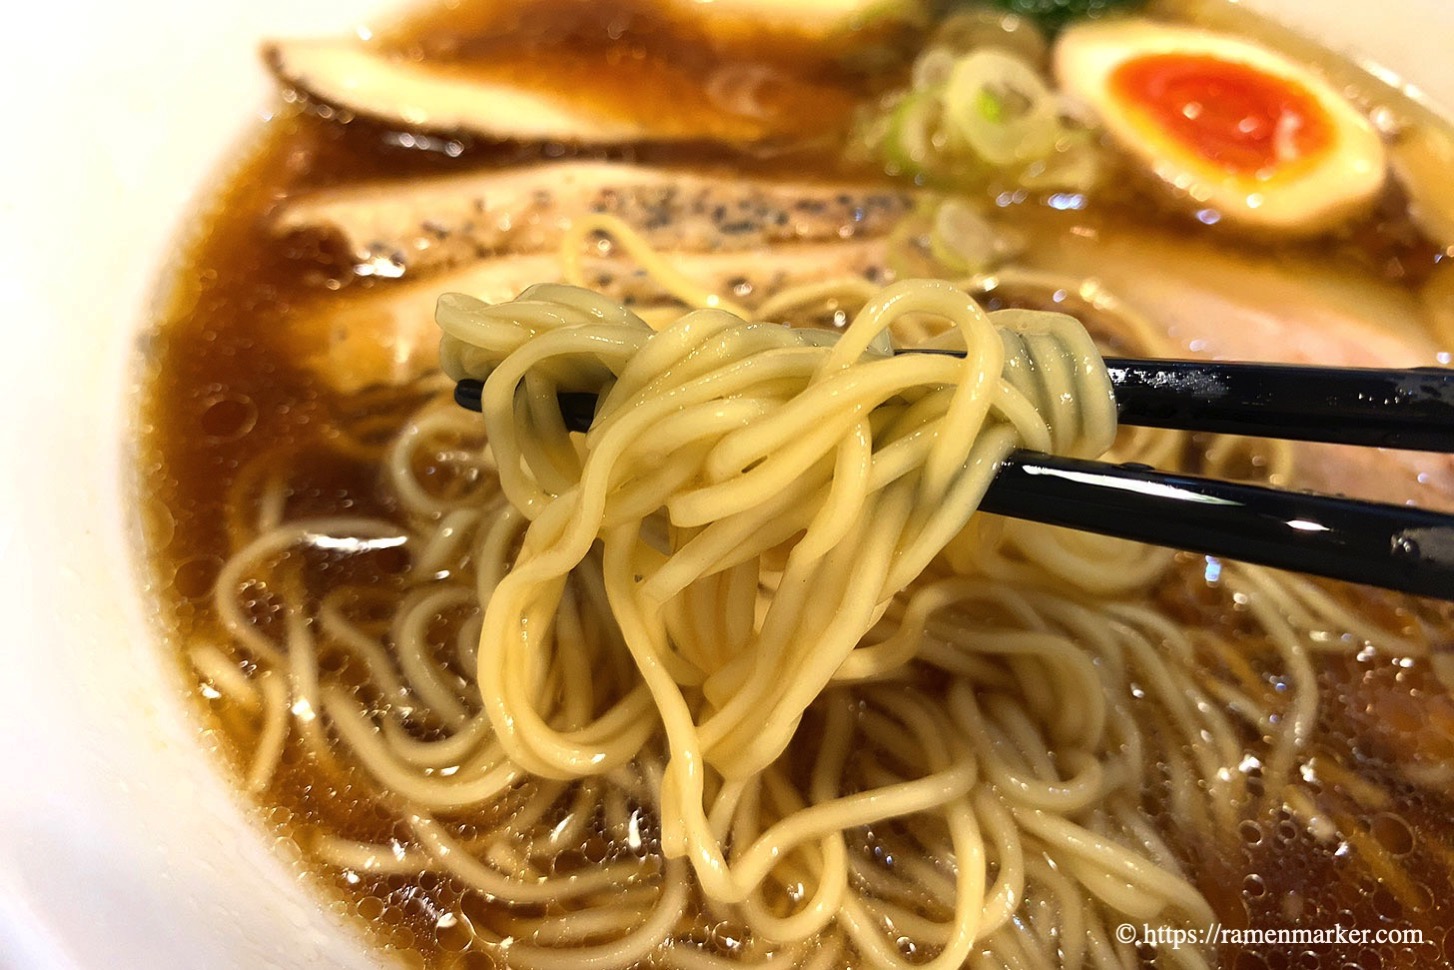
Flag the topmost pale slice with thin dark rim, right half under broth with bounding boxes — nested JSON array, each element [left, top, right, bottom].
[[263, 38, 855, 145]]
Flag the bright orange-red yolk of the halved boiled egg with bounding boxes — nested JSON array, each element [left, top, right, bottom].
[[1111, 54, 1333, 175]]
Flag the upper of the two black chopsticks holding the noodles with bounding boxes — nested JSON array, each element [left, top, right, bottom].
[[455, 356, 1454, 452]]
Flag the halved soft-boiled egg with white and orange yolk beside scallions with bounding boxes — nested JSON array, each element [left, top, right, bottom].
[[1056, 20, 1387, 233]]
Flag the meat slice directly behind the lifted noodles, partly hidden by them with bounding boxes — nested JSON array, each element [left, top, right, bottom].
[[286, 240, 890, 393]]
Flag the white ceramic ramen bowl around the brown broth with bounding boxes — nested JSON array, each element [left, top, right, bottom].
[[0, 0, 1454, 970]]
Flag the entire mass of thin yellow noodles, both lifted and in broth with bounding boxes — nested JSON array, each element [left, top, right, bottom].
[[178, 102, 1442, 970]]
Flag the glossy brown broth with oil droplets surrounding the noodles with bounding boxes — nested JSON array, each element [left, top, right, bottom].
[[138, 0, 1454, 970]]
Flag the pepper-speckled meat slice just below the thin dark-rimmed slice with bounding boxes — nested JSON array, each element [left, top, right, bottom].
[[272, 161, 913, 276]]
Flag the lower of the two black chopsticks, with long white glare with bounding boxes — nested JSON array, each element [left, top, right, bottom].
[[455, 372, 1454, 601]]
